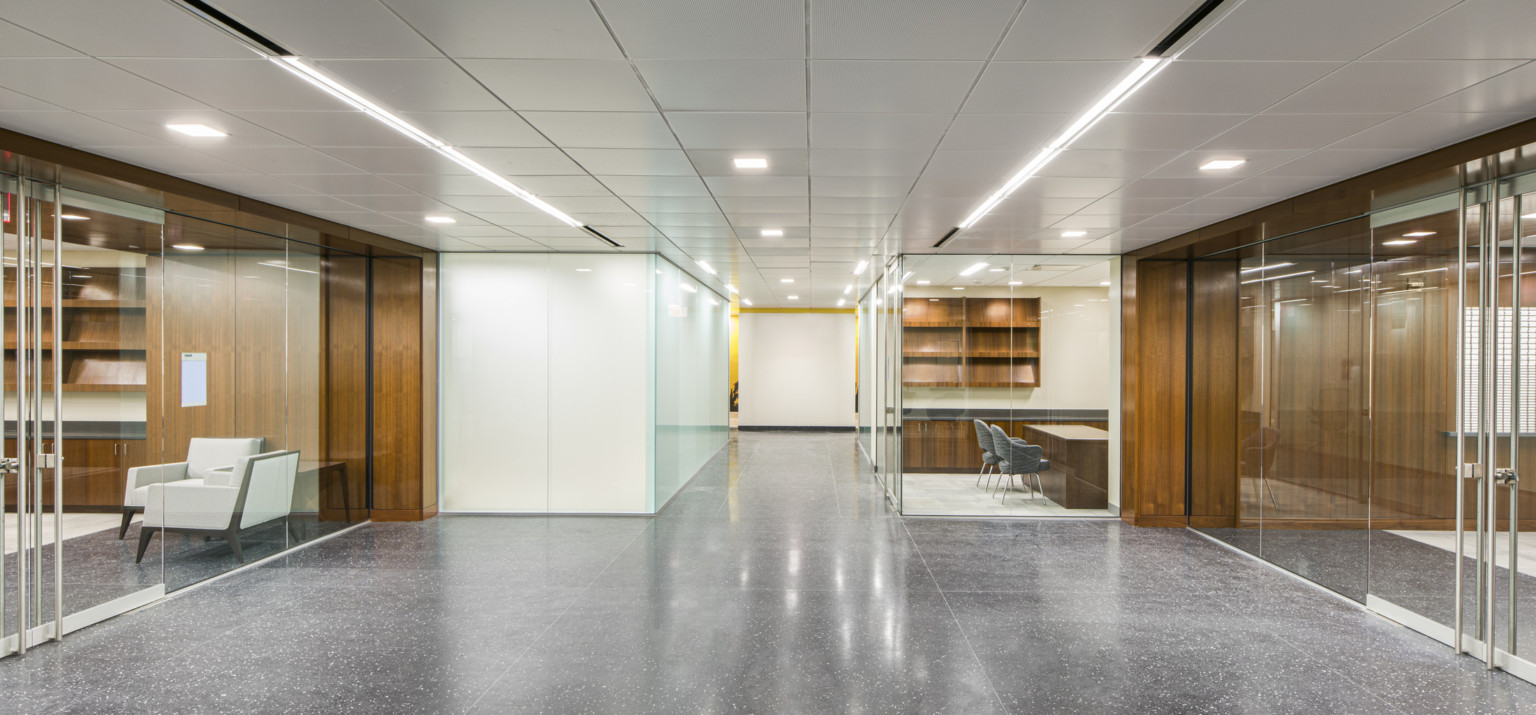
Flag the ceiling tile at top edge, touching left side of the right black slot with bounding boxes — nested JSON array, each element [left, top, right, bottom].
[[997, 0, 1193, 60]]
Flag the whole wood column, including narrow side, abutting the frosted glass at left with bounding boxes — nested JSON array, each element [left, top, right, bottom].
[[372, 254, 438, 521]]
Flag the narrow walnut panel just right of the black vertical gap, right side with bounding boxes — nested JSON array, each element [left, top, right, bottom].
[[1189, 260, 1240, 518]]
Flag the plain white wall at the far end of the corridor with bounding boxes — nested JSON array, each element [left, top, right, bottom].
[[736, 312, 857, 427]]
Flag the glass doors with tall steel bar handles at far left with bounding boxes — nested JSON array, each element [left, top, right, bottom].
[[0, 175, 164, 655]]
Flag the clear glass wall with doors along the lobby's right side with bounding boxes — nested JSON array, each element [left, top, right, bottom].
[[1189, 156, 1536, 678]]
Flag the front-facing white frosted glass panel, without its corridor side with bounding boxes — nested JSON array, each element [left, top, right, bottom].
[[439, 254, 653, 514]]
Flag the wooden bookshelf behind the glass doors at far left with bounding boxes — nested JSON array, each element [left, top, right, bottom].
[[5, 266, 146, 392]]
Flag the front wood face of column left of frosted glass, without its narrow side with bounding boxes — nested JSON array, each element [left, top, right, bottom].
[[372, 258, 423, 518]]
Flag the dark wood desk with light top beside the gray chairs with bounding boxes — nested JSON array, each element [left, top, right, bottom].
[[1021, 424, 1109, 509]]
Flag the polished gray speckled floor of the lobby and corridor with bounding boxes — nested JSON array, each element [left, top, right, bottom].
[[0, 434, 1536, 713]]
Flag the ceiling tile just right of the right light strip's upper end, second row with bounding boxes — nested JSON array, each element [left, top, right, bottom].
[[1118, 60, 1341, 114]]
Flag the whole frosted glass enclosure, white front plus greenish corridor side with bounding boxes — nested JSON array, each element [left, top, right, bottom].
[[439, 254, 728, 514]]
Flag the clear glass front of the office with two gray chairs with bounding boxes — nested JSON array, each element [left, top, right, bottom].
[[888, 255, 1120, 518]]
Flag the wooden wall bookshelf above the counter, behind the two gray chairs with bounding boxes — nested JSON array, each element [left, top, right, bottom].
[[902, 298, 1040, 387]]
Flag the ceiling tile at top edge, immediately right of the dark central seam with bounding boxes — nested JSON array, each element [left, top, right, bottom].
[[806, 0, 1020, 60]]
